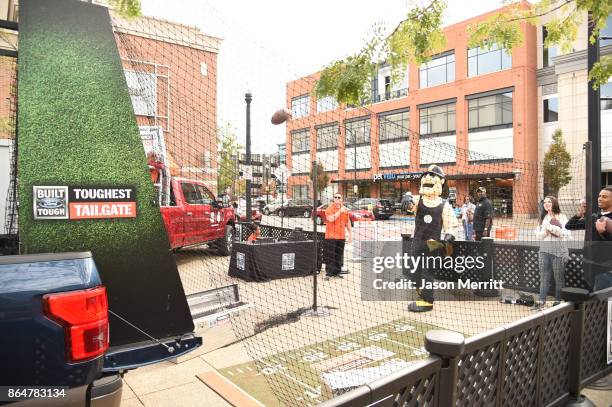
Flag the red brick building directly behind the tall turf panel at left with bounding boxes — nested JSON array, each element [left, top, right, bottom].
[[112, 14, 221, 194]]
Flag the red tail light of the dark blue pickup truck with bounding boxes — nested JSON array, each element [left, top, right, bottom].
[[43, 287, 108, 362]]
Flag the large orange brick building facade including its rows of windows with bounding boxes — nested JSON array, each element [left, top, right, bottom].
[[286, 5, 538, 216]]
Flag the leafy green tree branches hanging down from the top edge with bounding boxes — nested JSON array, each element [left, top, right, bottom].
[[314, 0, 612, 105]]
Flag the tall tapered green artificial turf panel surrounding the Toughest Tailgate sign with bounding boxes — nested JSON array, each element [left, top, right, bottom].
[[18, 0, 193, 344]]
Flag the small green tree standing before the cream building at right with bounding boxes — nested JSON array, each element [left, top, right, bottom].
[[544, 129, 572, 197]]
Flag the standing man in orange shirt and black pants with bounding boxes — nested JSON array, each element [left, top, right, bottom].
[[325, 194, 351, 278]]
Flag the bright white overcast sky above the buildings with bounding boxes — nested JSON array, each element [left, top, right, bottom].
[[142, 0, 502, 153]]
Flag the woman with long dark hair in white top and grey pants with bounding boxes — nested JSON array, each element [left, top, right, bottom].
[[536, 196, 570, 306]]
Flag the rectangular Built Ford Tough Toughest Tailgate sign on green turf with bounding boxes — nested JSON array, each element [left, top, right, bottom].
[[32, 186, 136, 220]]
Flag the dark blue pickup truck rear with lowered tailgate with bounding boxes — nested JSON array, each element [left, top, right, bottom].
[[0, 252, 201, 407]]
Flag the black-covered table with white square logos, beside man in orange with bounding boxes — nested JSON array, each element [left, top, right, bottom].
[[229, 240, 315, 281]]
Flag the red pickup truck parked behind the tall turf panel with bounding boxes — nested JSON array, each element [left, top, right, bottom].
[[160, 178, 236, 256]]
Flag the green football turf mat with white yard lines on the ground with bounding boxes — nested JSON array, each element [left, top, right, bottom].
[[219, 318, 439, 406]]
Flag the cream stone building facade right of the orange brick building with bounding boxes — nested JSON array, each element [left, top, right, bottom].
[[537, 11, 612, 205]]
